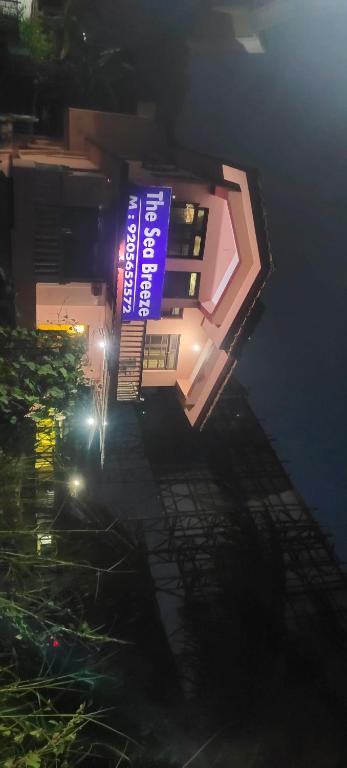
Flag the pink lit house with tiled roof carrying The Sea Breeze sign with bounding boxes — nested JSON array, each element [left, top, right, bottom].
[[2, 109, 271, 432]]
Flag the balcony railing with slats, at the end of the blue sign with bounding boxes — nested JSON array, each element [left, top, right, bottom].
[[116, 322, 146, 401]]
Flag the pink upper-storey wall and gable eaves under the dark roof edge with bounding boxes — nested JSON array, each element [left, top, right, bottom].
[[130, 163, 261, 424]]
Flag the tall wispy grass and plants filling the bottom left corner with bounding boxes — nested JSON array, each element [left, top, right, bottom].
[[0, 432, 147, 768]]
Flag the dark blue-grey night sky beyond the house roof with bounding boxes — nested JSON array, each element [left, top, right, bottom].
[[178, 10, 347, 560]]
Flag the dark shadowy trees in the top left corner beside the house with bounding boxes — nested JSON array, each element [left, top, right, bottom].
[[0, 0, 198, 135]]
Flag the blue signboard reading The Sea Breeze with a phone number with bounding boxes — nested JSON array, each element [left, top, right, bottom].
[[122, 187, 171, 320]]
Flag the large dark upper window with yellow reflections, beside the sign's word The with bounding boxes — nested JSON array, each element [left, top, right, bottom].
[[167, 203, 208, 259]]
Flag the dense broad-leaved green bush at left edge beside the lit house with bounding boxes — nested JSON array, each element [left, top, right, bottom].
[[0, 327, 85, 424]]
